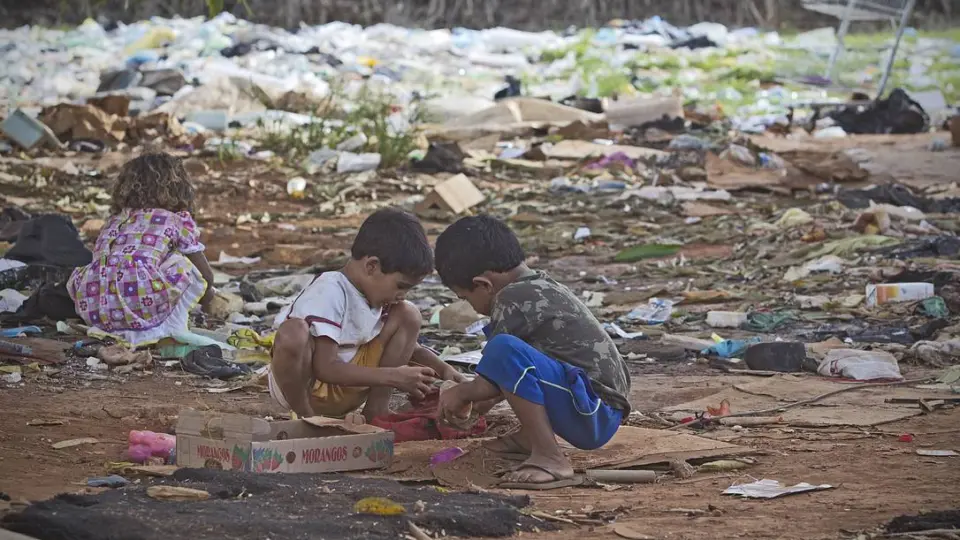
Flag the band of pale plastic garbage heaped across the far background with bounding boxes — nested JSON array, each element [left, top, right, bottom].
[[0, 13, 960, 154]]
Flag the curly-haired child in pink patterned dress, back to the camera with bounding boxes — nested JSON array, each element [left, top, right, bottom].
[[67, 153, 213, 347]]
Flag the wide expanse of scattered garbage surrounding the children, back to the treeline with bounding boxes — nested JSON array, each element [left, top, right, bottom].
[[0, 15, 960, 400]]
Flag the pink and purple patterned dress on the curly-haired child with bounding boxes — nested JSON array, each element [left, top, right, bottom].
[[67, 208, 207, 347]]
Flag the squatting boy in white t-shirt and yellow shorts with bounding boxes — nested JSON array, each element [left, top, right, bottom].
[[269, 209, 463, 421]]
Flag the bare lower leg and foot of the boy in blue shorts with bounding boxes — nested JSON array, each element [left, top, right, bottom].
[[503, 392, 574, 484]]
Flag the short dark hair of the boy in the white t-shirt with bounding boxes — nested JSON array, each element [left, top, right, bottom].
[[350, 208, 433, 277]]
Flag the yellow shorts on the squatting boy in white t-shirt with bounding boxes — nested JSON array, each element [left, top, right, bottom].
[[268, 338, 383, 418]]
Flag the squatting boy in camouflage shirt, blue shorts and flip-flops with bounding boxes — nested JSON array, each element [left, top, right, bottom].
[[435, 216, 630, 489]]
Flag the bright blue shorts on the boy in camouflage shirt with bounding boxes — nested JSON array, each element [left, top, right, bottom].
[[477, 334, 623, 450]]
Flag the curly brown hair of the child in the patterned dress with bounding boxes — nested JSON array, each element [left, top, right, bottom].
[[110, 152, 196, 214]]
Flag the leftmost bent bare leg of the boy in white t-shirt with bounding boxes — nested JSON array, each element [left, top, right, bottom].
[[270, 319, 314, 418]]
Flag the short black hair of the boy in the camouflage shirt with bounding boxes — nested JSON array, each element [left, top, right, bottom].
[[436, 215, 526, 291]]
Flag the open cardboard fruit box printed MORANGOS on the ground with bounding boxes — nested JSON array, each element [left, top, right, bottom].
[[177, 409, 394, 473]]
